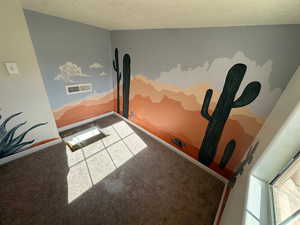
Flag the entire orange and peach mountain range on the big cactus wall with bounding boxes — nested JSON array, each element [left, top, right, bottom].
[[130, 75, 263, 176]]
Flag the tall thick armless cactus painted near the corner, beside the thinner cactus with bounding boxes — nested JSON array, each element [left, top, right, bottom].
[[123, 54, 130, 118]]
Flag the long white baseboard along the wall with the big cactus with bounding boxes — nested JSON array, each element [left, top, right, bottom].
[[113, 112, 228, 184]]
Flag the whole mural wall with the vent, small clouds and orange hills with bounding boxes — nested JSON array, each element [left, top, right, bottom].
[[24, 10, 114, 128]]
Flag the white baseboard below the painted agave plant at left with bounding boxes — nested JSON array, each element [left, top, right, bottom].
[[0, 138, 62, 165]]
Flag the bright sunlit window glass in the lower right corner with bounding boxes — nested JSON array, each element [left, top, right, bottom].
[[271, 152, 300, 225]]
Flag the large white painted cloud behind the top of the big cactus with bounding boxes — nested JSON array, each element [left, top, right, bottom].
[[157, 52, 282, 117]]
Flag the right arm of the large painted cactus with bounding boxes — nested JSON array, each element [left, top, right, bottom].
[[232, 81, 261, 108]]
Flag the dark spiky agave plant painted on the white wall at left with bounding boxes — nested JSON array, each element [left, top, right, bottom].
[[0, 112, 47, 158]]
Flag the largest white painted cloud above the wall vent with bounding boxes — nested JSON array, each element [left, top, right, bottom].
[[54, 62, 90, 83]]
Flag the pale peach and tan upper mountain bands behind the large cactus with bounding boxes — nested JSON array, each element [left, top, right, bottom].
[[130, 75, 264, 135]]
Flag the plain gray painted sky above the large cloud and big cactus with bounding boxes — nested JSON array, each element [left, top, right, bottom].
[[112, 25, 300, 88]]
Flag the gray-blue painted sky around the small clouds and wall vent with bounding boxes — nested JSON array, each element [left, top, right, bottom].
[[25, 10, 113, 109]]
